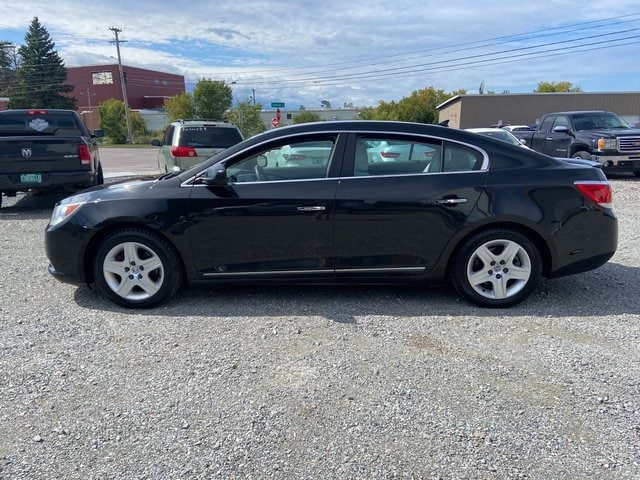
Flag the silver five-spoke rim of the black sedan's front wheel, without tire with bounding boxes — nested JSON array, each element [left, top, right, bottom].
[[102, 242, 165, 301]]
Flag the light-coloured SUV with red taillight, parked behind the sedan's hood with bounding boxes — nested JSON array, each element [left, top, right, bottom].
[[151, 120, 243, 173]]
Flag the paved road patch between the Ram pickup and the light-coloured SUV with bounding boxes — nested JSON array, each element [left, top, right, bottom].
[[100, 147, 159, 178]]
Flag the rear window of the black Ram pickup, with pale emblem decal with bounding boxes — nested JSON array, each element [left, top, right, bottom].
[[0, 113, 83, 137]]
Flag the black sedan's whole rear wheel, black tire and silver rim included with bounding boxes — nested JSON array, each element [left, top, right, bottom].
[[450, 228, 542, 308]]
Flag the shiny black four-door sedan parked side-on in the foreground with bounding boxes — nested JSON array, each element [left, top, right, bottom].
[[45, 121, 617, 308]]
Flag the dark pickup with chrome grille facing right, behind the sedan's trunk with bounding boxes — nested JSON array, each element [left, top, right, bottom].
[[511, 111, 640, 176]]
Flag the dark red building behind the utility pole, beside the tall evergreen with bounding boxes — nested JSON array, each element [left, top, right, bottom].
[[65, 64, 185, 129]]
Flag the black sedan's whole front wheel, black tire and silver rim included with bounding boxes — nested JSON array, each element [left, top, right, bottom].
[[94, 228, 184, 308]]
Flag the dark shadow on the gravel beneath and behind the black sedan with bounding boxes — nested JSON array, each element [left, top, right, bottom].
[[75, 263, 640, 324]]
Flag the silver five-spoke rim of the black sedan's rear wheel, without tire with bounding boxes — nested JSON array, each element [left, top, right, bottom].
[[466, 239, 532, 300]]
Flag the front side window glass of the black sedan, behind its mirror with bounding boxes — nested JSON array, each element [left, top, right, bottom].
[[226, 137, 336, 183]]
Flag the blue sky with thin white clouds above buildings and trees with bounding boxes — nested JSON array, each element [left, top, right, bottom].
[[0, 0, 640, 109]]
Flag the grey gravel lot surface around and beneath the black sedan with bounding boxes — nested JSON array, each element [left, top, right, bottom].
[[0, 177, 640, 480]]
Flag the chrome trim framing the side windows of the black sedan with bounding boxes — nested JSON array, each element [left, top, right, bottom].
[[180, 130, 489, 188]]
